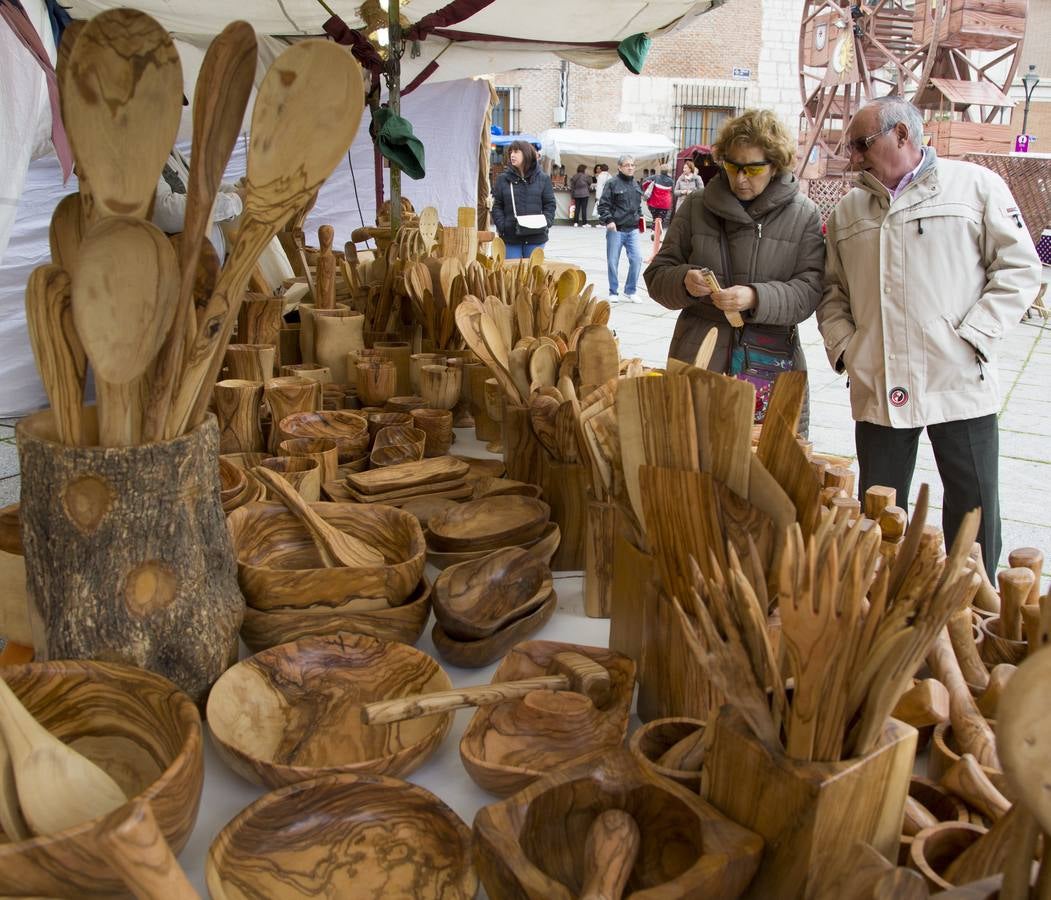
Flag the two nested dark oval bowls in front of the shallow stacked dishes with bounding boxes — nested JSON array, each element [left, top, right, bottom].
[[431, 547, 558, 668]]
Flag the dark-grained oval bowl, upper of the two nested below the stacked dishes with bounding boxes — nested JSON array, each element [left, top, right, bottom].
[[434, 547, 552, 640]]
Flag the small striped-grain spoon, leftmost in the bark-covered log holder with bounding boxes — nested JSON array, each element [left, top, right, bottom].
[[25, 263, 87, 446]]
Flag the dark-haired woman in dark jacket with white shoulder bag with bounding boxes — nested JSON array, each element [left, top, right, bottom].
[[493, 141, 555, 260]]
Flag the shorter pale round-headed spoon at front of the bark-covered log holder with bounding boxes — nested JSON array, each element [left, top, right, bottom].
[[73, 216, 179, 447]]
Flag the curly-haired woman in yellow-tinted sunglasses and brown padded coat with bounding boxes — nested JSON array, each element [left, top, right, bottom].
[[643, 109, 825, 432]]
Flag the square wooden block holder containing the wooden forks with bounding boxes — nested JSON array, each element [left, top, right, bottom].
[[701, 707, 916, 900]]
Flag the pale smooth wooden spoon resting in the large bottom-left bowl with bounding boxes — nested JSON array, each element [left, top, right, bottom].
[[0, 678, 127, 835]]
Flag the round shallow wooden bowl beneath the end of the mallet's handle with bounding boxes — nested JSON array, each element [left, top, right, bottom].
[[207, 632, 453, 788]]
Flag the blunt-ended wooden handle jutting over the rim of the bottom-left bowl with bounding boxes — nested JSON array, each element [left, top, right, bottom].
[[101, 800, 200, 900]]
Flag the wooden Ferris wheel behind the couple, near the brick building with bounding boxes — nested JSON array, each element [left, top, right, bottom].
[[799, 0, 1028, 178]]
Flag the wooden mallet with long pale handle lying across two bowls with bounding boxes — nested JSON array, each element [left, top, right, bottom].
[[362, 651, 610, 724]]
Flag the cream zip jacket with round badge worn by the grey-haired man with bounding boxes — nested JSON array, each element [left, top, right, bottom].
[[818, 148, 1040, 428]]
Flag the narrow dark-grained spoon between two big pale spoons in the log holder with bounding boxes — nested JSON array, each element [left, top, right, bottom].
[[143, 22, 256, 442]]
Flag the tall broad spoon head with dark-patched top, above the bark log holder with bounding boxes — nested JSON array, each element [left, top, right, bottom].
[[62, 8, 183, 221]]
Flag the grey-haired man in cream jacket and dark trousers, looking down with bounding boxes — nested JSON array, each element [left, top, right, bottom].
[[818, 97, 1040, 577]]
